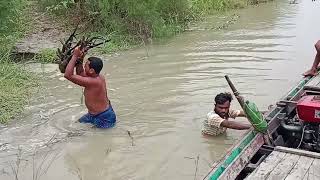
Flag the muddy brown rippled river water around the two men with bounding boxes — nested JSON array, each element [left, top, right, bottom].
[[0, 0, 320, 180]]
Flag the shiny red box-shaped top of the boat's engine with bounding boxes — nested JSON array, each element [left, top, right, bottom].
[[297, 95, 320, 123]]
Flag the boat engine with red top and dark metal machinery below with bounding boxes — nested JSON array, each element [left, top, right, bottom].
[[280, 95, 320, 152]]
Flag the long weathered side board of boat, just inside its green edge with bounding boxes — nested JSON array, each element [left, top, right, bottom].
[[219, 134, 264, 180]]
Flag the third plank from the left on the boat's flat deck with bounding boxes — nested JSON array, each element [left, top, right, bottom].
[[285, 156, 314, 180]]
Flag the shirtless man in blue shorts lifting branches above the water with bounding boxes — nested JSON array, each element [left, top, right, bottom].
[[64, 47, 116, 128]]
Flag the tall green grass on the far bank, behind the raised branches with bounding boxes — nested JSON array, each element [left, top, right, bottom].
[[38, 0, 262, 49]]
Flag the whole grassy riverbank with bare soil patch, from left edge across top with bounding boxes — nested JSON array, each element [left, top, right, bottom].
[[0, 0, 272, 123]]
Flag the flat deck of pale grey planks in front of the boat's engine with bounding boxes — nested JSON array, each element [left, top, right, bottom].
[[246, 147, 320, 180]]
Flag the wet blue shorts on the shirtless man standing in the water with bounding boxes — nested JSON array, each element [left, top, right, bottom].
[[79, 104, 116, 128]]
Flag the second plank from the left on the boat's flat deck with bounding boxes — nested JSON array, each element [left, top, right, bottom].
[[267, 154, 300, 180]]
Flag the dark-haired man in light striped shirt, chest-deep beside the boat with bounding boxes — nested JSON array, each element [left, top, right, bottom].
[[202, 93, 251, 136]]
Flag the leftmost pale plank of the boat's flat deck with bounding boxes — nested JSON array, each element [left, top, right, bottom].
[[246, 151, 286, 180]]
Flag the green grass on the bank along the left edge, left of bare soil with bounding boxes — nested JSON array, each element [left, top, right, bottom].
[[0, 0, 36, 123]]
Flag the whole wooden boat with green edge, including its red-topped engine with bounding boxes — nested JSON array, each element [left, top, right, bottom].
[[204, 75, 320, 180]]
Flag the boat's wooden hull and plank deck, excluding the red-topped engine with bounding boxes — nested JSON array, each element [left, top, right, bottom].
[[204, 74, 320, 180]]
